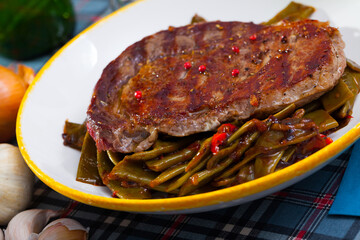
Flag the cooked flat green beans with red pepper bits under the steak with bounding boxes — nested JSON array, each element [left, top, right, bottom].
[[63, 3, 360, 199]]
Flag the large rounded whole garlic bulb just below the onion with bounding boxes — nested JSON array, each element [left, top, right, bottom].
[[0, 143, 34, 225]]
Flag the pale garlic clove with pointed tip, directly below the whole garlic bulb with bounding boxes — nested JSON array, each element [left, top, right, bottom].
[[5, 209, 62, 240]]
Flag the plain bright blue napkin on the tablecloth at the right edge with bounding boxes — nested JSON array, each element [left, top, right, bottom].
[[329, 140, 360, 216]]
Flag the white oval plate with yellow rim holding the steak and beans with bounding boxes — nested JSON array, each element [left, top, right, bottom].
[[17, 0, 360, 213]]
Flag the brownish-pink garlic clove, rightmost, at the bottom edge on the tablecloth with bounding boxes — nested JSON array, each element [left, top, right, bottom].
[[38, 218, 88, 240]]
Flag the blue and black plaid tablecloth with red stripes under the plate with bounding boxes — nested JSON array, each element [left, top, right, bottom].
[[0, 0, 360, 240]]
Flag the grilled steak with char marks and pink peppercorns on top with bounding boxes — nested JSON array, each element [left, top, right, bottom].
[[87, 20, 346, 152]]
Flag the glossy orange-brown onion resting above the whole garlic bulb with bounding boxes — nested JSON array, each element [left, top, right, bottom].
[[0, 66, 27, 143]]
